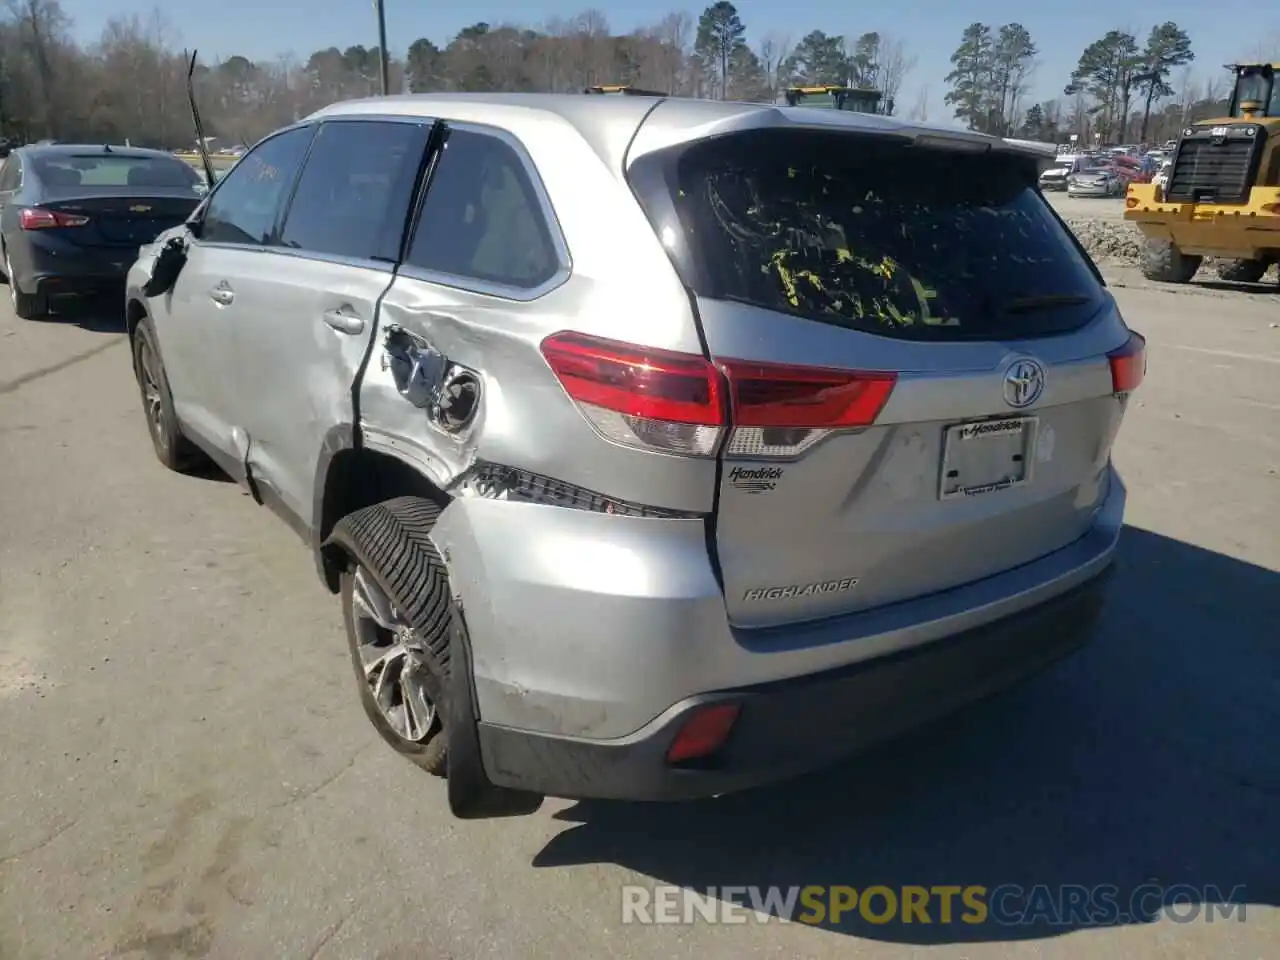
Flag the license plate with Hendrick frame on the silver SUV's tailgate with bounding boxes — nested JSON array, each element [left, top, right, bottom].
[[938, 417, 1038, 500]]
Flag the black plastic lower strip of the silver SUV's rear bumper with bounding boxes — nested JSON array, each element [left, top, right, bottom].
[[479, 567, 1110, 800]]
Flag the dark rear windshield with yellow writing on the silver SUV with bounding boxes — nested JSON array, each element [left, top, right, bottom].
[[631, 131, 1103, 339]]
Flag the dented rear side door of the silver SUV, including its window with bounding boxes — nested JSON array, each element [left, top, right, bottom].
[[225, 116, 434, 529]]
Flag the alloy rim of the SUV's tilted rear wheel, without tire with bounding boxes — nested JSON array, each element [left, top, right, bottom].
[[352, 567, 436, 744]]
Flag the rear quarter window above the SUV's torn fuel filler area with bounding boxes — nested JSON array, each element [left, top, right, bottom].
[[408, 131, 559, 289]]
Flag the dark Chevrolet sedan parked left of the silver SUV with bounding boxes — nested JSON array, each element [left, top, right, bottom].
[[0, 143, 206, 319]]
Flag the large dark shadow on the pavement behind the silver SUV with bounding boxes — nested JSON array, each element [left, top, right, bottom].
[[534, 527, 1280, 945]]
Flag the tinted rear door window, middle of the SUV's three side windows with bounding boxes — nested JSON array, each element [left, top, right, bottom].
[[280, 120, 428, 260]]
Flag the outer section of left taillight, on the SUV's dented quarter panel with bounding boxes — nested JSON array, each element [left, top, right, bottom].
[[543, 333, 724, 457]]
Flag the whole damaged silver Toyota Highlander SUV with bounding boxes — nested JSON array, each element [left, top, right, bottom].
[[128, 95, 1144, 817]]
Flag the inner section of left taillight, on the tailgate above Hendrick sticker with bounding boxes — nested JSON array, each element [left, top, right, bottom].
[[719, 360, 897, 458]]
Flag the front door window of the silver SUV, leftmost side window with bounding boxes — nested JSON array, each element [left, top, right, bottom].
[[200, 127, 315, 244]]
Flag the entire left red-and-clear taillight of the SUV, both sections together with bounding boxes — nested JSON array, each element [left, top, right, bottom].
[[541, 333, 897, 458]]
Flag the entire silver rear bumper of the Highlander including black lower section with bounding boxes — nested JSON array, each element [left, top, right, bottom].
[[431, 470, 1125, 799]]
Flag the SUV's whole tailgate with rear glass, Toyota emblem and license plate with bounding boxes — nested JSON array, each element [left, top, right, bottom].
[[628, 122, 1142, 627]]
